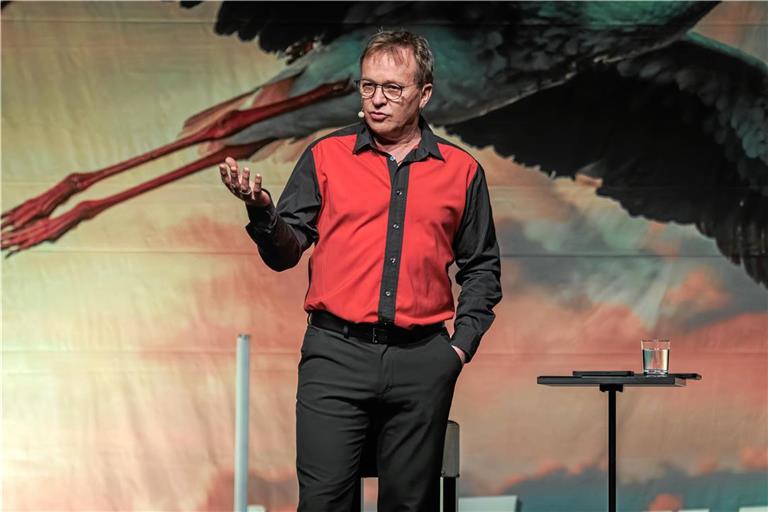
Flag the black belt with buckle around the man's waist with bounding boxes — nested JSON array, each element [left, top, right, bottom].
[[309, 311, 445, 345]]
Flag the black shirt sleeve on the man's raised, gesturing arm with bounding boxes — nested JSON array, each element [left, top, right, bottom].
[[245, 146, 321, 272]]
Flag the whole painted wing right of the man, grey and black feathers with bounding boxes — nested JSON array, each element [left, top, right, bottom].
[[446, 34, 768, 286]]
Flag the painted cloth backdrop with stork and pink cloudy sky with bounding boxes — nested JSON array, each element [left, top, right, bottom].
[[2, 2, 768, 512]]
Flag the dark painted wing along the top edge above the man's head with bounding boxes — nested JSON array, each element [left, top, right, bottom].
[[180, 0, 717, 63]]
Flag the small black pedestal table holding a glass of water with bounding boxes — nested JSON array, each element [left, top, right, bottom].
[[536, 370, 701, 512]]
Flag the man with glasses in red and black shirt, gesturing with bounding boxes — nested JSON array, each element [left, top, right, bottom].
[[219, 31, 501, 512]]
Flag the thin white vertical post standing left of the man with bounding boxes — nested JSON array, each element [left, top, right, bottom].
[[235, 334, 251, 512]]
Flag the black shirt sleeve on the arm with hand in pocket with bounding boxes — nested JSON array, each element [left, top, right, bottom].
[[451, 165, 501, 362]]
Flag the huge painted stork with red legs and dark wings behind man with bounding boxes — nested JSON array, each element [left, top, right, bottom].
[[2, 2, 768, 285]]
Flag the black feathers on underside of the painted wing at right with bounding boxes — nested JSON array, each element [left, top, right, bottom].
[[447, 59, 768, 286]]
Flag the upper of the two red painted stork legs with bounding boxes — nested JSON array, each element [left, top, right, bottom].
[[2, 80, 351, 231]]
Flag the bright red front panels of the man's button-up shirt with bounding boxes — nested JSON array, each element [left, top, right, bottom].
[[304, 130, 477, 328]]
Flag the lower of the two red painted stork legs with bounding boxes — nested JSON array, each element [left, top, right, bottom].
[[0, 139, 274, 256]]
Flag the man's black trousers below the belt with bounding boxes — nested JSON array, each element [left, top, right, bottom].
[[296, 325, 462, 512]]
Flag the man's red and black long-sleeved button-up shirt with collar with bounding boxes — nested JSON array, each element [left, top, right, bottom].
[[246, 119, 501, 360]]
